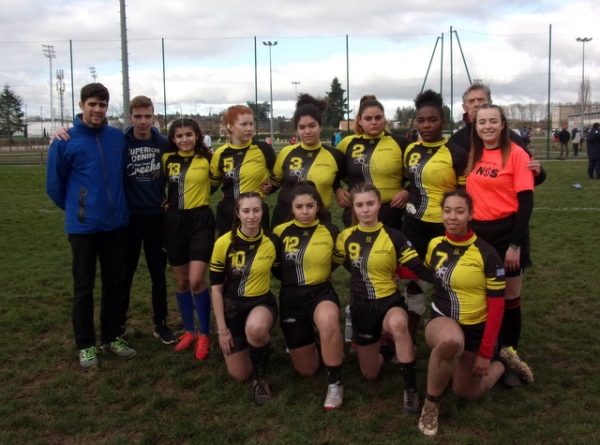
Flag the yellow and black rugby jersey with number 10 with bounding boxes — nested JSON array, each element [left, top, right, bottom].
[[210, 229, 279, 298]]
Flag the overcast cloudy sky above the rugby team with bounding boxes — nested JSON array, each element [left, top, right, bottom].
[[0, 0, 600, 121]]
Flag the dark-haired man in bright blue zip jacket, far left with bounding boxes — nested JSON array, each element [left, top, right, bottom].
[[46, 83, 136, 370]]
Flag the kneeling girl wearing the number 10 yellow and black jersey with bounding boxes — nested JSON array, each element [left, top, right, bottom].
[[210, 192, 279, 405]]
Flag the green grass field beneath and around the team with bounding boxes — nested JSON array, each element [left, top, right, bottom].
[[0, 161, 600, 444]]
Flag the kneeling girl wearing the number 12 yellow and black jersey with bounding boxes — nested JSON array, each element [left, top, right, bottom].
[[273, 181, 344, 410]]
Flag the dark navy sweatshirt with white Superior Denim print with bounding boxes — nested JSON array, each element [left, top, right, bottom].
[[125, 126, 167, 215]]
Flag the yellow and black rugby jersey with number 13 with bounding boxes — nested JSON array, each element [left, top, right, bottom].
[[162, 152, 210, 210]]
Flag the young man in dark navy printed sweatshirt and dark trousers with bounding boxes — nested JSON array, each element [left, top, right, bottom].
[[120, 96, 177, 344]]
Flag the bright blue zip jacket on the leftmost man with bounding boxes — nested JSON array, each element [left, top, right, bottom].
[[46, 116, 129, 234]]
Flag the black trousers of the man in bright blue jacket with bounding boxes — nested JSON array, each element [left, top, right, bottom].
[[69, 227, 127, 349]]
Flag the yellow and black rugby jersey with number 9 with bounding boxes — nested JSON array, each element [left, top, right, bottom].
[[333, 223, 431, 300]]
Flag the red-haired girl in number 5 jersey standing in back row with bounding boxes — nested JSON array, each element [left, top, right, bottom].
[[210, 105, 275, 235]]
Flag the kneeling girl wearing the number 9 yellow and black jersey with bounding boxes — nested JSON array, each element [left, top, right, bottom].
[[334, 184, 432, 414]]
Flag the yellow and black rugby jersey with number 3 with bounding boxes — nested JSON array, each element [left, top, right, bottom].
[[271, 144, 346, 210]]
